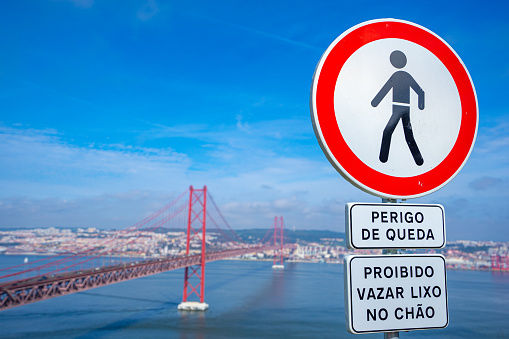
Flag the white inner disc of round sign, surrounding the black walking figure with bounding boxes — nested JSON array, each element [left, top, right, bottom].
[[334, 39, 461, 177]]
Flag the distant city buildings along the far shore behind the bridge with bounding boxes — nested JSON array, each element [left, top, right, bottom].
[[0, 227, 509, 271]]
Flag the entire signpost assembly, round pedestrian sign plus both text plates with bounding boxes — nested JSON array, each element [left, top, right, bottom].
[[310, 19, 479, 338]]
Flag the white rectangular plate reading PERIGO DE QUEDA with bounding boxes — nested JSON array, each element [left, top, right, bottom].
[[345, 203, 445, 249]]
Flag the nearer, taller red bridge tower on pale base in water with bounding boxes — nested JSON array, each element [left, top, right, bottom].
[[178, 186, 209, 311]]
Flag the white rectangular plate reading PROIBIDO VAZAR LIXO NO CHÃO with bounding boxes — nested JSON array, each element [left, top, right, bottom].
[[345, 254, 449, 334]]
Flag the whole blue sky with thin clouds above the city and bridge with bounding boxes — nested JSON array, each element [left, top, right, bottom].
[[0, 0, 509, 241]]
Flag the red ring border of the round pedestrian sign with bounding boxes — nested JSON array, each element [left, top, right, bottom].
[[314, 21, 478, 197]]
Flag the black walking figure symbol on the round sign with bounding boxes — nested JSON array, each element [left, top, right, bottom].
[[371, 51, 424, 166]]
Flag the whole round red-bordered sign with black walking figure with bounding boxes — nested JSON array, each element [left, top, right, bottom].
[[310, 19, 478, 199]]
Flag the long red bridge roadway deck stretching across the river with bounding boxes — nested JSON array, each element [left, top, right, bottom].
[[0, 245, 286, 310]]
